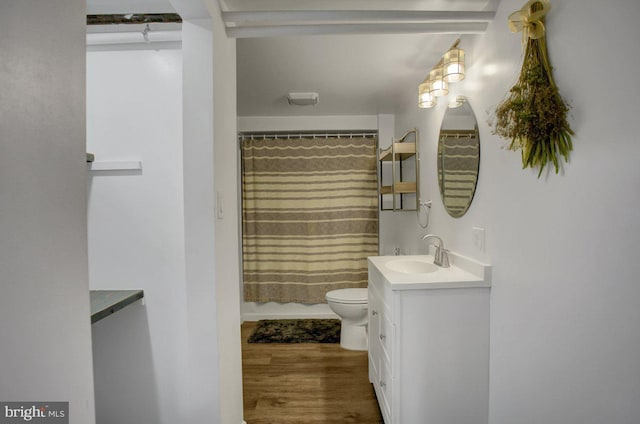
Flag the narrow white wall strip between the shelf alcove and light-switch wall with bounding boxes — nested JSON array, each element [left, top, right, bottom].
[[181, 19, 222, 424]]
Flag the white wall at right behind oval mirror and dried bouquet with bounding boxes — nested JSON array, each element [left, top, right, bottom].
[[388, 0, 640, 424]]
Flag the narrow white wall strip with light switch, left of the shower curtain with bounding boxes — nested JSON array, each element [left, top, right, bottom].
[[210, 2, 248, 424]]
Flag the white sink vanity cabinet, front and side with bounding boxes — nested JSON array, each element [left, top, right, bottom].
[[368, 257, 490, 424]]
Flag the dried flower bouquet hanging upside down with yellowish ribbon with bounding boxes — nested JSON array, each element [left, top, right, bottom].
[[493, 0, 573, 178]]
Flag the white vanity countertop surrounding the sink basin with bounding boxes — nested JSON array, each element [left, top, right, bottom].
[[369, 252, 491, 290]]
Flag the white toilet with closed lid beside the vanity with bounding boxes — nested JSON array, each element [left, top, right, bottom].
[[325, 289, 369, 350]]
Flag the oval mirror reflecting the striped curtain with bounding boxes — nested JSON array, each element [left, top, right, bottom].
[[438, 99, 480, 218]]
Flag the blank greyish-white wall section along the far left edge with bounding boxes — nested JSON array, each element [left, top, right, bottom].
[[0, 0, 95, 424]]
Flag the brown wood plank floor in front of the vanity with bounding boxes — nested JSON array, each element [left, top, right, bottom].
[[242, 322, 382, 424]]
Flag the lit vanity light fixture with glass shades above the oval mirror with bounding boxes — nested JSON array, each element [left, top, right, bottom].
[[418, 39, 465, 108]]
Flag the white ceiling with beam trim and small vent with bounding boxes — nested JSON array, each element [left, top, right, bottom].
[[87, 0, 500, 116]]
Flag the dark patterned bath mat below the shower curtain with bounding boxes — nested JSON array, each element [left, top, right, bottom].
[[248, 319, 340, 343]]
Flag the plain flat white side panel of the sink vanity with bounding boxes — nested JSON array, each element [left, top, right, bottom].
[[392, 288, 489, 424]]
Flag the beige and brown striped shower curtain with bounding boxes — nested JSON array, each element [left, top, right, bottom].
[[241, 137, 378, 303]]
